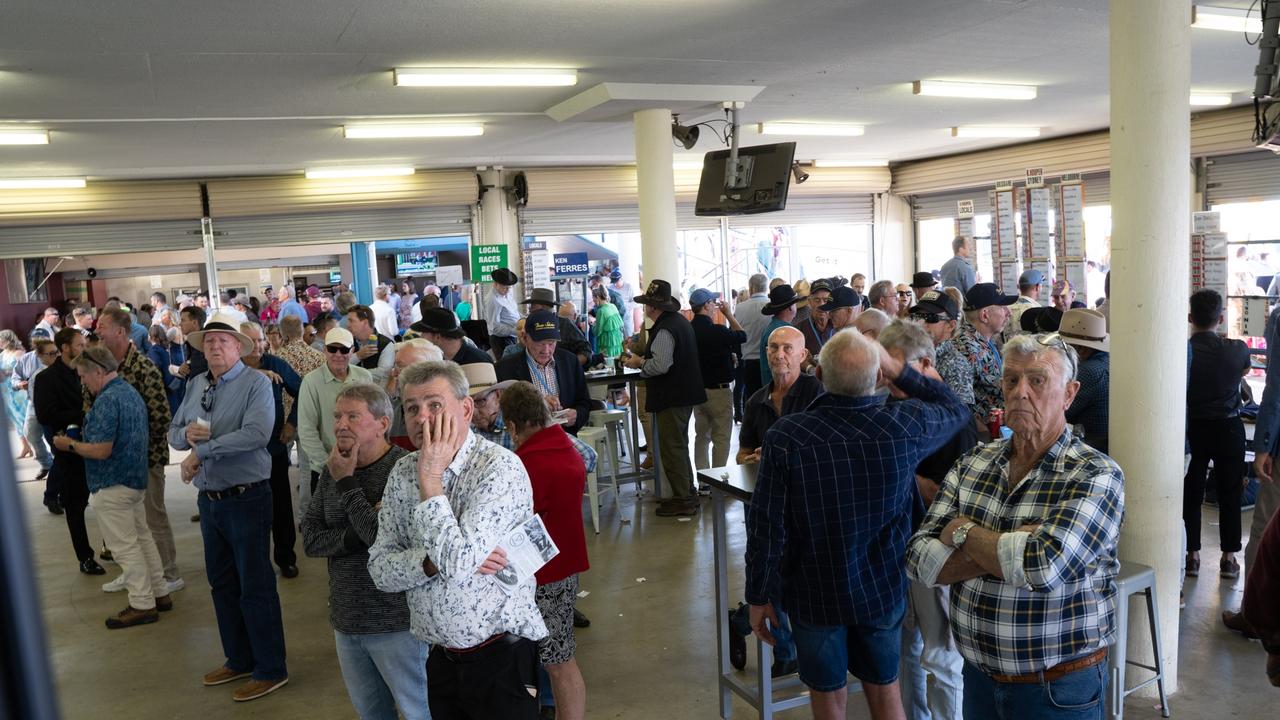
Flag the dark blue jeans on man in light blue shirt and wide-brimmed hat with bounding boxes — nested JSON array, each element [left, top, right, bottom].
[[196, 478, 289, 680]]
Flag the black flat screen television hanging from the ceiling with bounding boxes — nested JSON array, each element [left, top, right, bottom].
[[694, 142, 796, 215]]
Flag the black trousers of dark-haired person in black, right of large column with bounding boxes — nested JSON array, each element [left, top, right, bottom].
[[1183, 418, 1244, 552]]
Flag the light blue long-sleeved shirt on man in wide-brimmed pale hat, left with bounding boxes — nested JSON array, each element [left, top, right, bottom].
[[169, 361, 275, 491]]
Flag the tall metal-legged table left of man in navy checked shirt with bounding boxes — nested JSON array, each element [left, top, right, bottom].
[[698, 464, 861, 720]]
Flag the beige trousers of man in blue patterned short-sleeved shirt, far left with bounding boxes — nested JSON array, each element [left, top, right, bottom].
[[88, 486, 168, 610]]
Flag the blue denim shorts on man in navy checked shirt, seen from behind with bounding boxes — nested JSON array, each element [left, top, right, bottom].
[[791, 601, 906, 692]]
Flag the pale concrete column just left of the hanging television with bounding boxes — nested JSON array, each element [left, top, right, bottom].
[[634, 109, 684, 292]]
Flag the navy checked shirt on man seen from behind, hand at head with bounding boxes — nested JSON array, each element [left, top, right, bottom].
[[746, 368, 972, 625]]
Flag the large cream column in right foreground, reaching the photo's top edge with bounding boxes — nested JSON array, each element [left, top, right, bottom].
[[1107, 0, 1187, 697]]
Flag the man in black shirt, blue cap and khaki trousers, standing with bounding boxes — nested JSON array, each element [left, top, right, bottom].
[[689, 287, 746, 470]]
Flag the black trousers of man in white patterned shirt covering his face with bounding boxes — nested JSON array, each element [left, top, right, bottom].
[[426, 635, 538, 720]]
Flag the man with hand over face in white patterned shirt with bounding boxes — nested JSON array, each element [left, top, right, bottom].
[[369, 363, 547, 720]]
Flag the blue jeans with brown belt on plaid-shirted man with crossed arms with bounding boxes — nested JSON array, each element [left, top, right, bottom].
[[964, 661, 1107, 720]]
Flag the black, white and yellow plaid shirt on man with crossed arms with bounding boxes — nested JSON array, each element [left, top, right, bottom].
[[906, 430, 1124, 675]]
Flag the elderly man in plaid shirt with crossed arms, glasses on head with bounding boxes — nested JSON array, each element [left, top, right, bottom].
[[906, 336, 1124, 720]]
